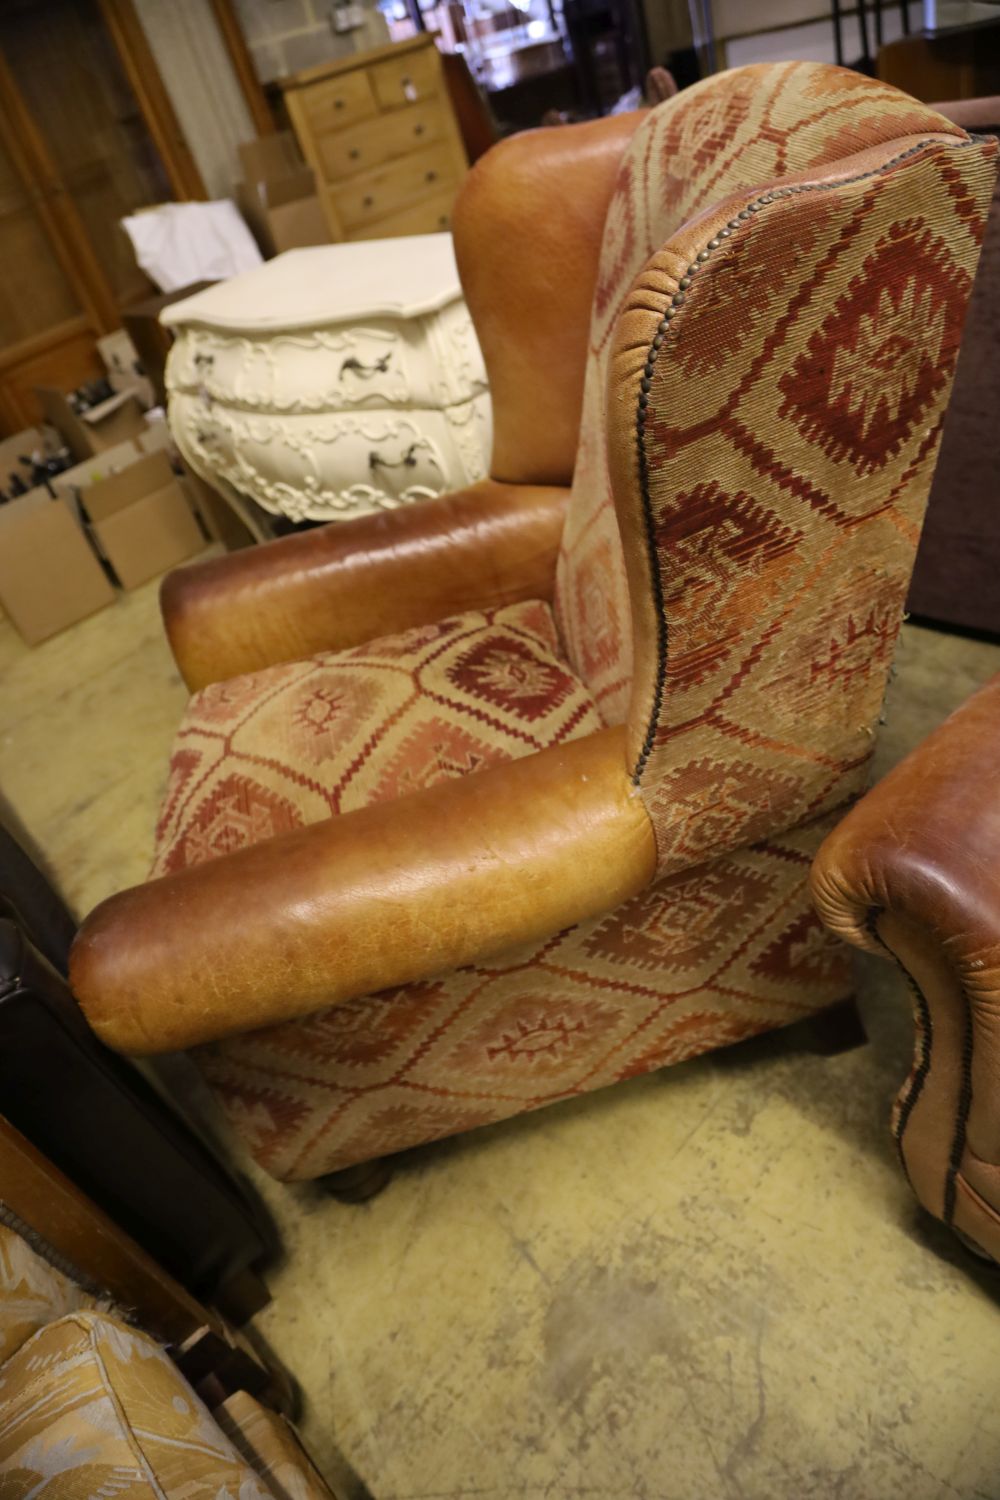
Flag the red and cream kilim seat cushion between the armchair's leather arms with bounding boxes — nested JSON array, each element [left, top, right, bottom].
[[151, 602, 600, 876]]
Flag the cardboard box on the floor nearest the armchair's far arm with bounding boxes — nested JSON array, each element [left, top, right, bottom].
[[82, 453, 205, 588]]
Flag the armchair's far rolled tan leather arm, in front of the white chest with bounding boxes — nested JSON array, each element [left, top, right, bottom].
[[160, 480, 568, 692]]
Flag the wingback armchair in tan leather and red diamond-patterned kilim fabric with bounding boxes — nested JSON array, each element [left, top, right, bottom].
[[72, 63, 997, 1179]]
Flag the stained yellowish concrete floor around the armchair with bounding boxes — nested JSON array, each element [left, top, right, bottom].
[[0, 587, 1000, 1500]]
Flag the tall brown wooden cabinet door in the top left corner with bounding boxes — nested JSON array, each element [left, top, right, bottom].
[[0, 0, 196, 432]]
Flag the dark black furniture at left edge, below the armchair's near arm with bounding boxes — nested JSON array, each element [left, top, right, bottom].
[[0, 825, 276, 1322]]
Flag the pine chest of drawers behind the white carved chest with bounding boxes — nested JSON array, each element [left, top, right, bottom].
[[282, 35, 468, 240]]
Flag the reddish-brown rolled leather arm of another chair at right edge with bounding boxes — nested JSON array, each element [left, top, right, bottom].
[[813, 677, 1000, 1260]]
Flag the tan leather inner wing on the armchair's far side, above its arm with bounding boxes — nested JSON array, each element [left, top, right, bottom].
[[453, 110, 645, 485]]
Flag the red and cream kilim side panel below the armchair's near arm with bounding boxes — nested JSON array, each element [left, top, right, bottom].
[[195, 819, 850, 1179]]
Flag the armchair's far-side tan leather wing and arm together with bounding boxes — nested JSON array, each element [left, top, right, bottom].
[[163, 113, 642, 690]]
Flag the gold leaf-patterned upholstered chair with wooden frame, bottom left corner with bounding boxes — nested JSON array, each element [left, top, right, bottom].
[[0, 1121, 336, 1500]]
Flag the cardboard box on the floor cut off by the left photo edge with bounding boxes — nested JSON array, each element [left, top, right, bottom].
[[0, 489, 114, 647]]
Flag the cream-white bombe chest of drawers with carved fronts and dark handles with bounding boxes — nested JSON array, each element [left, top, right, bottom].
[[163, 234, 492, 521]]
